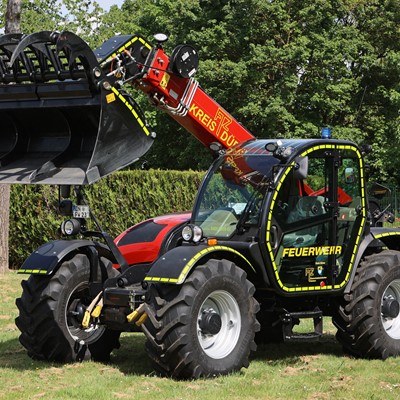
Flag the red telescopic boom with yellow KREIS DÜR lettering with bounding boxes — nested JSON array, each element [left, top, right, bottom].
[[132, 48, 254, 148]]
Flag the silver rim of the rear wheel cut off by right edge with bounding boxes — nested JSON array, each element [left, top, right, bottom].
[[381, 279, 400, 339]]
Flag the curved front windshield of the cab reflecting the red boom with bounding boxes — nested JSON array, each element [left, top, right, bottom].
[[193, 152, 279, 238]]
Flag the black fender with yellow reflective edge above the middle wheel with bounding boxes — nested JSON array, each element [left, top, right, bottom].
[[144, 245, 255, 285]]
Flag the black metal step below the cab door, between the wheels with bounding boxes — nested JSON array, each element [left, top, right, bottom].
[[281, 308, 323, 342]]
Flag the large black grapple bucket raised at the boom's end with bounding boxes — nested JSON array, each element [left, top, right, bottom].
[[0, 31, 153, 185]]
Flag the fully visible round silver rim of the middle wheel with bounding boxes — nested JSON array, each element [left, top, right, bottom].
[[197, 290, 241, 359]]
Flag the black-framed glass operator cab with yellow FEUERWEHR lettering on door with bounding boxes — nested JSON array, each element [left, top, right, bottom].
[[187, 139, 366, 292]]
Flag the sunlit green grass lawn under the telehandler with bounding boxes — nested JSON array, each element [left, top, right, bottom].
[[0, 272, 400, 400]]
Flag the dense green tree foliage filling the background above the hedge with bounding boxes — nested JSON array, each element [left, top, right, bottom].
[[3, 0, 400, 181]]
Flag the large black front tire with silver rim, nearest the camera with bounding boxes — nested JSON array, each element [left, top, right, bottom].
[[143, 260, 259, 379]]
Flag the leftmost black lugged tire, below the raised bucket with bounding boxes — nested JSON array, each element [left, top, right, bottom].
[[15, 254, 120, 363]]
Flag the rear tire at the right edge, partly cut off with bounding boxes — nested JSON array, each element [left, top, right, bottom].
[[333, 250, 400, 359]]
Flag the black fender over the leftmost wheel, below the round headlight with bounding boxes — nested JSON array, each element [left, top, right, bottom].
[[18, 240, 116, 280]]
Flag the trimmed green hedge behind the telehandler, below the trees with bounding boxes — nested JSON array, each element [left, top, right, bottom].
[[9, 170, 204, 268]]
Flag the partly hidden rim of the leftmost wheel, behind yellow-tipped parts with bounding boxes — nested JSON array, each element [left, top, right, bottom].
[[65, 283, 105, 344]]
